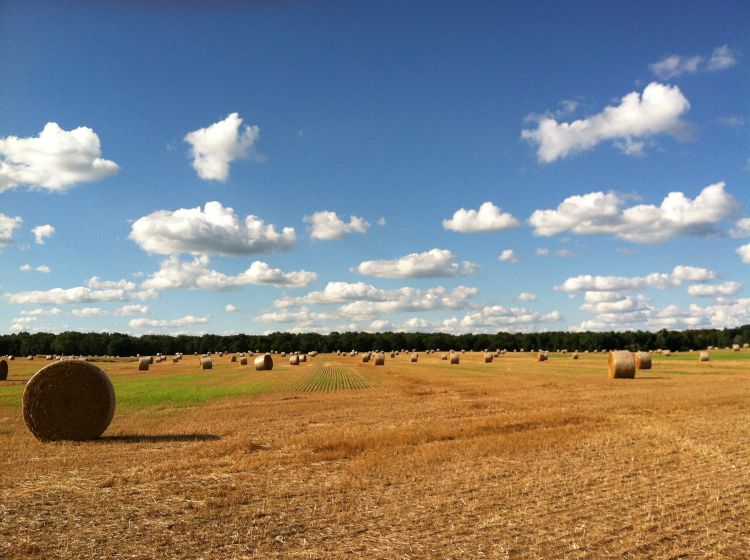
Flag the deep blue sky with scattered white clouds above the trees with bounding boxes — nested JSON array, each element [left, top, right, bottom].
[[0, 1, 750, 334]]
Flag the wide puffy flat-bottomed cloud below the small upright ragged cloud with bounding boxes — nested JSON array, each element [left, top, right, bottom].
[[130, 201, 296, 255]]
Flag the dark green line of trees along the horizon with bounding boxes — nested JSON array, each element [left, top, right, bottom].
[[0, 325, 750, 356]]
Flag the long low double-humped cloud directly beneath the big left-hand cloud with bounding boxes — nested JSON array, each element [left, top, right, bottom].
[[142, 256, 318, 290]]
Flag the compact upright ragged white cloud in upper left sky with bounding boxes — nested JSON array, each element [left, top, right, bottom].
[[185, 113, 262, 181]]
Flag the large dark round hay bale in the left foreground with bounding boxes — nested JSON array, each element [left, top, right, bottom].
[[23, 360, 115, 441]]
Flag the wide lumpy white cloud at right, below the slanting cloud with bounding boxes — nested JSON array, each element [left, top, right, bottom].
[[528, 182, 737, 243]]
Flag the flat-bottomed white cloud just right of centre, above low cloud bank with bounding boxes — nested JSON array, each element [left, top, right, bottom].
[[355, 249, 478, 278]]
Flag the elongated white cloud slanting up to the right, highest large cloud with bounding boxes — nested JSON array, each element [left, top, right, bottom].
[[521, 82, 690, 163]]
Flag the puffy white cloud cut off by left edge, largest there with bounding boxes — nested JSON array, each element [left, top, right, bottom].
[[0, 122, 120, 192]]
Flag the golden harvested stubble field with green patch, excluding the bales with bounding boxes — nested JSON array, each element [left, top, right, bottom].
[[0, 350, 750, 559]]
